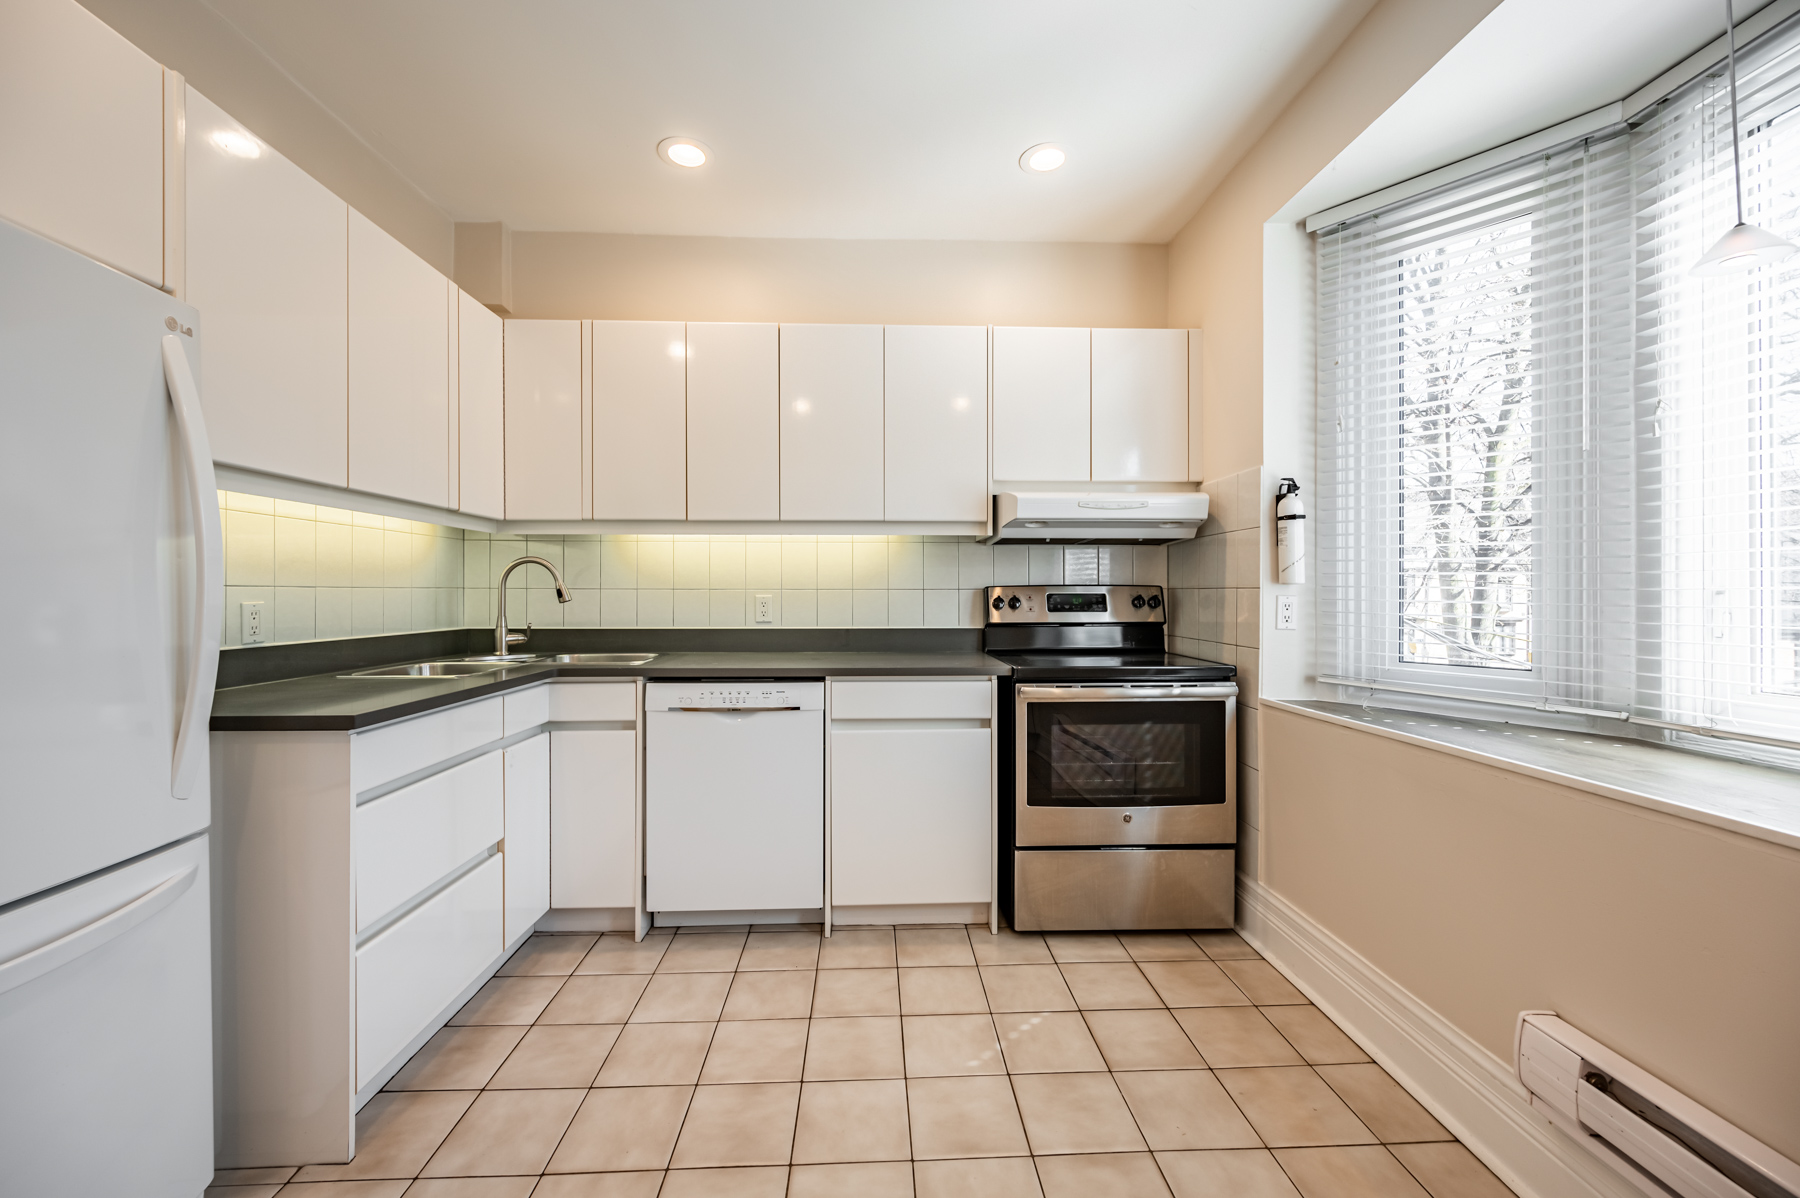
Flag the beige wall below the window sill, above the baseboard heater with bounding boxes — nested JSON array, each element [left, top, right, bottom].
[[1262, 707, 1800, 1158]]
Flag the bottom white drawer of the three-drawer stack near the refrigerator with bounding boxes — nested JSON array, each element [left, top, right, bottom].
[[356, 854, 504, 1090]]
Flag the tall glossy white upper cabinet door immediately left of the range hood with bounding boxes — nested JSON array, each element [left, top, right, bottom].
[[886, 326, 988, 520]]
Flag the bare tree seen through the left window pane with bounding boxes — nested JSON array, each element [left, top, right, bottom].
[[1397, 219, 1537, 669]]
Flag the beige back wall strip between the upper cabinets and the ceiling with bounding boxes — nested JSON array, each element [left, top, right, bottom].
[[513, 230, 1168, 327]]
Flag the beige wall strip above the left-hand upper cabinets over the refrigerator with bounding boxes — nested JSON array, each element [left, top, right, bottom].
[[81, 0, 454, 275]]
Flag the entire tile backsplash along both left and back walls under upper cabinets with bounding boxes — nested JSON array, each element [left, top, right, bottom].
[[220, 491, 1168, 646]]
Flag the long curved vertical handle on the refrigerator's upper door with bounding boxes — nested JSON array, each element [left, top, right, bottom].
[[162, 333, 225, 799]]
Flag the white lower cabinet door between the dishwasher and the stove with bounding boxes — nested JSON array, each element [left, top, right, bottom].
[[832, 725, 994, 907]]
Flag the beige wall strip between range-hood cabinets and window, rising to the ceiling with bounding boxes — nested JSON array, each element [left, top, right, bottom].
[[1168, 0, 1498, 478]]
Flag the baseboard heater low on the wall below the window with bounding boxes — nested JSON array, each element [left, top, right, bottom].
[[1514, 1011, 1800, 1198]]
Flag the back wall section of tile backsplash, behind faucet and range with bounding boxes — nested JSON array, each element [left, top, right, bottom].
[[461, 532, 1168, 628]]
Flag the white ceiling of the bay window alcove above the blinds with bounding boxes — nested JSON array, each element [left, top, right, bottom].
[[1280, 0, 1769, 219]]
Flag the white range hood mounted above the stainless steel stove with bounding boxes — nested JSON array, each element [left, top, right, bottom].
[[983, 491, 1206, 545]]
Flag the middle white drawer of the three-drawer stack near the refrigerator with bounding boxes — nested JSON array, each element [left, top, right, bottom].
[[351, 752, 506, 932]]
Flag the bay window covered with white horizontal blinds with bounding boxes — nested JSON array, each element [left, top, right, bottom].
[[1316, 16, 1800, 754]]
